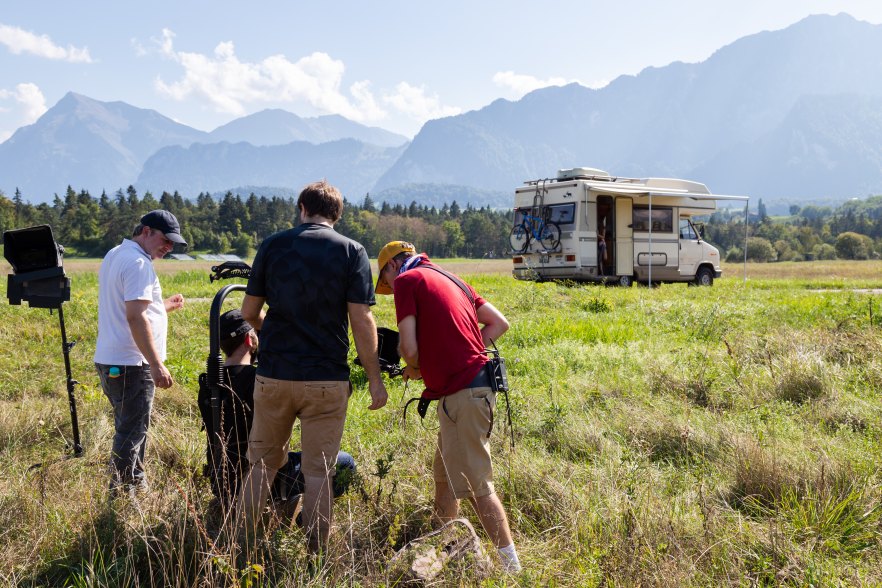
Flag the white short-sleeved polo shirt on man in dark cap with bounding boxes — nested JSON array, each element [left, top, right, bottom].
[[94, 239, 168, 365]]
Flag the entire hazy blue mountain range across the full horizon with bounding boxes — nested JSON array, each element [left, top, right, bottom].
[[0, 14, 882, 206]]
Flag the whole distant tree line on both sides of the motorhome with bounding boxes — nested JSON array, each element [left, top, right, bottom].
[[0, 186, 882, 262]]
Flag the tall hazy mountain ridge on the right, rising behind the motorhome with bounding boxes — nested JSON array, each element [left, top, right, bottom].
[[375, 10, 882, 198]]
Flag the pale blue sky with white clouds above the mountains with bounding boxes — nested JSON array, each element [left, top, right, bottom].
[[0, 0, 882, 141]]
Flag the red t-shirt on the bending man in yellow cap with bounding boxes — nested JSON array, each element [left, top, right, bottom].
[[395, 263, 487, 399]]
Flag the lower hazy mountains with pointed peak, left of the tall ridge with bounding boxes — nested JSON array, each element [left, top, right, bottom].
[[0, 92, 407, 202]]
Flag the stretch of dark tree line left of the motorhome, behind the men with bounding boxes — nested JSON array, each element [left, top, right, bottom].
[[0, 186, 512, 257]]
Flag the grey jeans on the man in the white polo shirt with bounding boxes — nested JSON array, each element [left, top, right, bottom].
[[95, 363, 156, 488]]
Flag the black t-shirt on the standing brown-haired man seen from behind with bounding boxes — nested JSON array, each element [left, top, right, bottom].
[[246, 223, 376, 381]]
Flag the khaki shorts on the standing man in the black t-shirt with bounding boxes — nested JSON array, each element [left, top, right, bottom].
[[248, 376, 351, 476]]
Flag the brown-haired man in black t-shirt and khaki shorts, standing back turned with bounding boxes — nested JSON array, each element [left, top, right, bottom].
[[240, 181, 387, 552]]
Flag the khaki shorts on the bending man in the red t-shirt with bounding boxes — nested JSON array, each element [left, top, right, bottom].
[[432, 387, 496, 498]]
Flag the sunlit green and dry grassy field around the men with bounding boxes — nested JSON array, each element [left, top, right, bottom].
[[0, 262, 882, 586]]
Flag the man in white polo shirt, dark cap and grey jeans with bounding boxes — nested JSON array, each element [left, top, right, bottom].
[[94, 210, 187, 491]]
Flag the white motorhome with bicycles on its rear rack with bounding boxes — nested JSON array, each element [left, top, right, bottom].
[[510, 167, 747, 286]]
